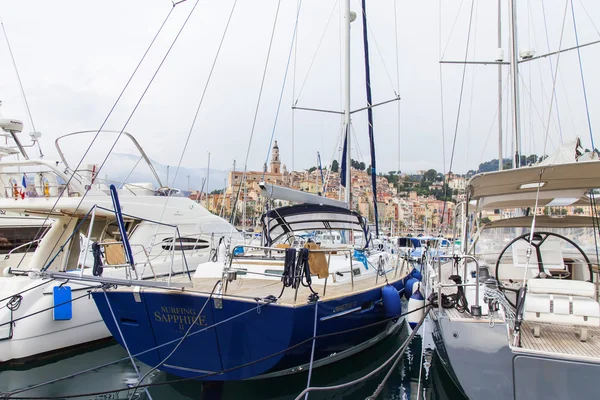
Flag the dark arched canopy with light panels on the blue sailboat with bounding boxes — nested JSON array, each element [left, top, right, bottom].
[[261, 204, 369, 246]]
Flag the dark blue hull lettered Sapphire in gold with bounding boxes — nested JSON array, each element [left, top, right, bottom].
[[93, 280, 403, 380]]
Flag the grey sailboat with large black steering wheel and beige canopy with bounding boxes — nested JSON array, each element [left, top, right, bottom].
[[426, 1, 600, 399]]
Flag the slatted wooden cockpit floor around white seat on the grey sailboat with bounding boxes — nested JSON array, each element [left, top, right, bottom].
[[509, 321, 600, 362]]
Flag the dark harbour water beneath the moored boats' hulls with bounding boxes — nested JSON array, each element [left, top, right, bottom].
[[0, 325, 463, 400]]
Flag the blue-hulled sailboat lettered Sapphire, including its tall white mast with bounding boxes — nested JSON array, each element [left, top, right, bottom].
[[82, 1, 417, 381]]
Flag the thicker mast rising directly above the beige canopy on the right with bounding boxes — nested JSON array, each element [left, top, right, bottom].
[[509, 0, 521, 168]]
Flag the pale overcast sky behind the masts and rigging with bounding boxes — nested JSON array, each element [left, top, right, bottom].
[[0, 0, 600, 184]]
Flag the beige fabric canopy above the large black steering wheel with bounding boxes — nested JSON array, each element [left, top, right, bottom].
[[467, 161, 600, 209]]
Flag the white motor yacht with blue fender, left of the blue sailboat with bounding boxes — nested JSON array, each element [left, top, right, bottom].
[[0, 133, 237, 362]]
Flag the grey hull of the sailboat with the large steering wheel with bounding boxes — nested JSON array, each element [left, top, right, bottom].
[[432, 310, 600, 400]]
